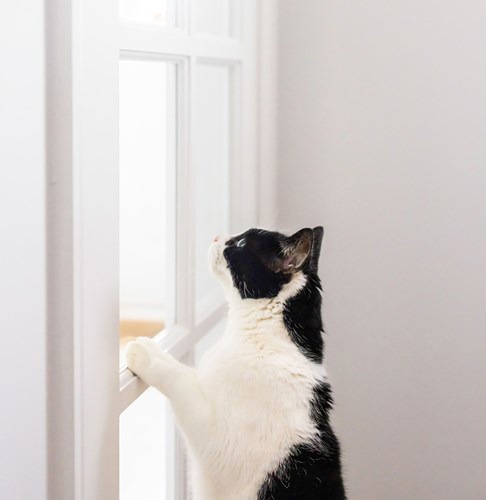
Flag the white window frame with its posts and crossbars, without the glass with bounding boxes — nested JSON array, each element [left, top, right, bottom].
[[46, 0, 276, 500]]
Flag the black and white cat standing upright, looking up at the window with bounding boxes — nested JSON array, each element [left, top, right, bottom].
[[126, 227, 346, 500]]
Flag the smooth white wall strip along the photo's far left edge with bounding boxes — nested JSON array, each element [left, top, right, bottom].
[[0, 0, 46, 500]]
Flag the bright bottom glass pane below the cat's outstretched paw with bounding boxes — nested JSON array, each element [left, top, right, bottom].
[[120, 388, 169, 500]]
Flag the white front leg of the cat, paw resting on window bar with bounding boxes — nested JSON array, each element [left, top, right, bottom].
[[126, 337, 214, 448]]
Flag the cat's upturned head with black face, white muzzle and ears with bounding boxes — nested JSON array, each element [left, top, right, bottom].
[[209, 226, 324, 299]]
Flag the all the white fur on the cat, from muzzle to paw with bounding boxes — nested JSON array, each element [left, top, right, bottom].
[[127, 242, 326, 500]]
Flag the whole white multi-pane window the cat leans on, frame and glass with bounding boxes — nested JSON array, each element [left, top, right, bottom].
[[48, 0, 274, 500]]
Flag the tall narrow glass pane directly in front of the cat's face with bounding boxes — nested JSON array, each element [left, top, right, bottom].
[[193, 64, 230, 314]]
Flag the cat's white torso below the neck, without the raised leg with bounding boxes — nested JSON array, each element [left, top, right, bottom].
[[190, 310, 326, 500]]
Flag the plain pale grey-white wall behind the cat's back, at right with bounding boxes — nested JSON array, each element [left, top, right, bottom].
[[279, 0, 486, 500]]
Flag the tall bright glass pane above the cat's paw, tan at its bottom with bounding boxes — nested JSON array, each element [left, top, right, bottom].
[[119, 60, 175, 364]]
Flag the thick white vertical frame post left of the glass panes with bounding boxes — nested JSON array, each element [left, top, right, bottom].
[[46, 0, 118, 500]]
